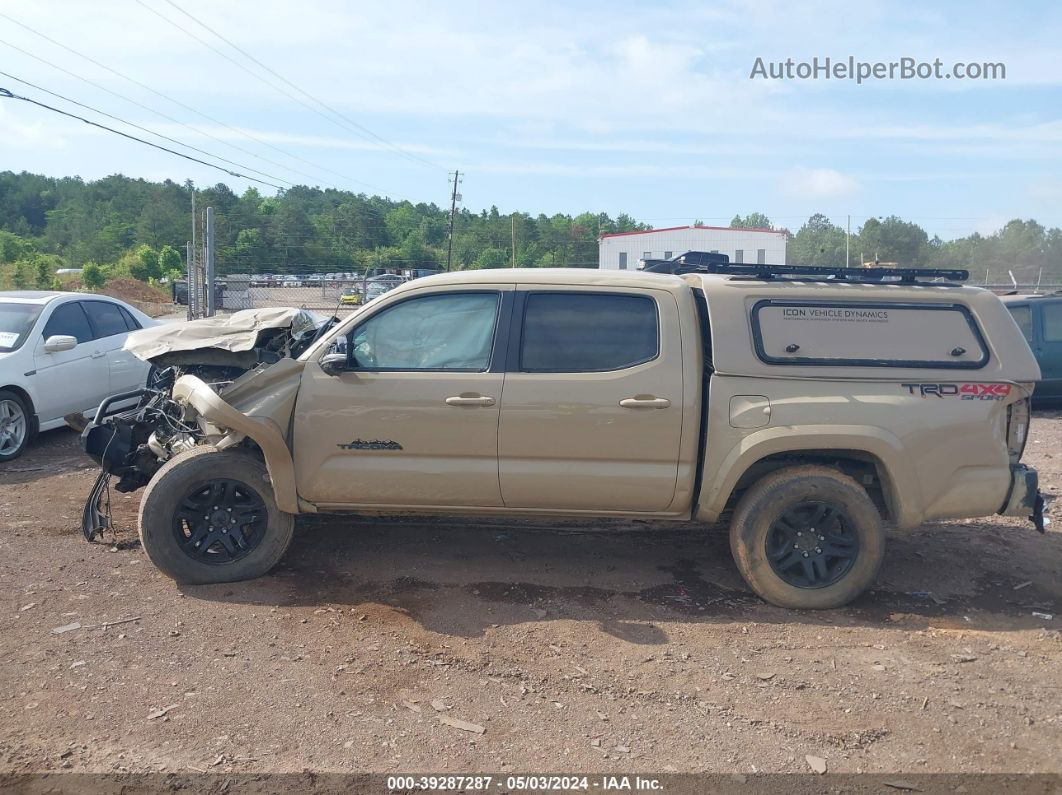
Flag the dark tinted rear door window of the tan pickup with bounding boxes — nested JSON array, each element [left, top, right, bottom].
[[519, 293, 660, 373]]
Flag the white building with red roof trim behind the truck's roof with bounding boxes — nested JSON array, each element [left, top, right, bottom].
[[598, 226, 786, 271]]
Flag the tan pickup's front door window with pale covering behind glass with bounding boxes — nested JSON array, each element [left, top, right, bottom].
[[347, 293, 498, 373]]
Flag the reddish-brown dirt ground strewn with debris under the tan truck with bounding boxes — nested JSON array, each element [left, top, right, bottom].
[[0, 412, 1062, 773]]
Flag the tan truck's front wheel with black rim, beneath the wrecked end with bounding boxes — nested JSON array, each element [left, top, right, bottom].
[[140, 447, 295, 585]]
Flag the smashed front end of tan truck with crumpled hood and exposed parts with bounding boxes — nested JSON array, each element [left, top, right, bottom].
[[80, 309, 322, 541]]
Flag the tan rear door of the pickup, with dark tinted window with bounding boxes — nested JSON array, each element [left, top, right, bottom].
[[498, 286, 683, 512]]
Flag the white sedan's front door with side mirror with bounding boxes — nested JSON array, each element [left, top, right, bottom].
[[33, 300, 104, 424]]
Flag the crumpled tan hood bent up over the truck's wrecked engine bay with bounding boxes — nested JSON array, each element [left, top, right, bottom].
[[123, 307, 319, 362]]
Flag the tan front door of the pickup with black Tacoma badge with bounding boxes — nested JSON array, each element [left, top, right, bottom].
[[294, 287, 512, 507]]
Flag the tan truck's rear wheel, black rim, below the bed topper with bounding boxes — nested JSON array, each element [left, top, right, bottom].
[[730, 465, 885, 609]]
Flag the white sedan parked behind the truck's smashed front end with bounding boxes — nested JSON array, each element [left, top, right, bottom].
[[0, 291, 159, 462]]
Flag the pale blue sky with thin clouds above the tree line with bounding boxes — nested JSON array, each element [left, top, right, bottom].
[[0, 0, 1062, 239]]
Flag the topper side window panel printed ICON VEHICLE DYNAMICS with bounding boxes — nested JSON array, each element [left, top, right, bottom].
[[751, 299, 989, 369]]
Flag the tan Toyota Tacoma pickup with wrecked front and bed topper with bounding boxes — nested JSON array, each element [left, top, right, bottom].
[[85, 265, 1045, 608]]
